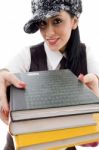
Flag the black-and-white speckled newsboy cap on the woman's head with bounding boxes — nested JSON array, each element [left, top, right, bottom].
[[24, 0, 82, 33]]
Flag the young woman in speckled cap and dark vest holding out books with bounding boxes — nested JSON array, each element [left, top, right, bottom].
[[0, 0, 99, 150]]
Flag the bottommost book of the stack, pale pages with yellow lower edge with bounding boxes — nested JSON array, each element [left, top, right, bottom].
[[17, 133, 99, 150]]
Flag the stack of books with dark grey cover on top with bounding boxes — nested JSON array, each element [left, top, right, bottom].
[[9, 69, 99, 150]]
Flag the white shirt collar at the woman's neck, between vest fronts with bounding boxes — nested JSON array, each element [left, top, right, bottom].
[[44, 42, 63, 69]]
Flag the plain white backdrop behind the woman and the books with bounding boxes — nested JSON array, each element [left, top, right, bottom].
[[0, 0, 99, 150]]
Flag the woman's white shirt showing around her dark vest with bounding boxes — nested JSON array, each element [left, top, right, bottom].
[[6, 43, 99, 75]]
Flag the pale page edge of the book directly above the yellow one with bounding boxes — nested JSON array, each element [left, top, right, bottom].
[[9, 114, 96, 135]]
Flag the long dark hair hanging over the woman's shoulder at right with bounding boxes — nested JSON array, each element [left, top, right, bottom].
[[65, 27, 87, 76]]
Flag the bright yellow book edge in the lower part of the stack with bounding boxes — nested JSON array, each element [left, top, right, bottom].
[[14, 125, 99, 147]]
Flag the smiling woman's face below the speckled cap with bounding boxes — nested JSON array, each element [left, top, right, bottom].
[[40, 11, 78, 52]]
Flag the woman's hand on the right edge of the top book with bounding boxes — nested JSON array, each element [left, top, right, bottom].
[[78, 73, 99, 97]]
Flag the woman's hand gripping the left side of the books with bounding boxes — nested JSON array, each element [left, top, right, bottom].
[[0, 70, 26, 124]]
